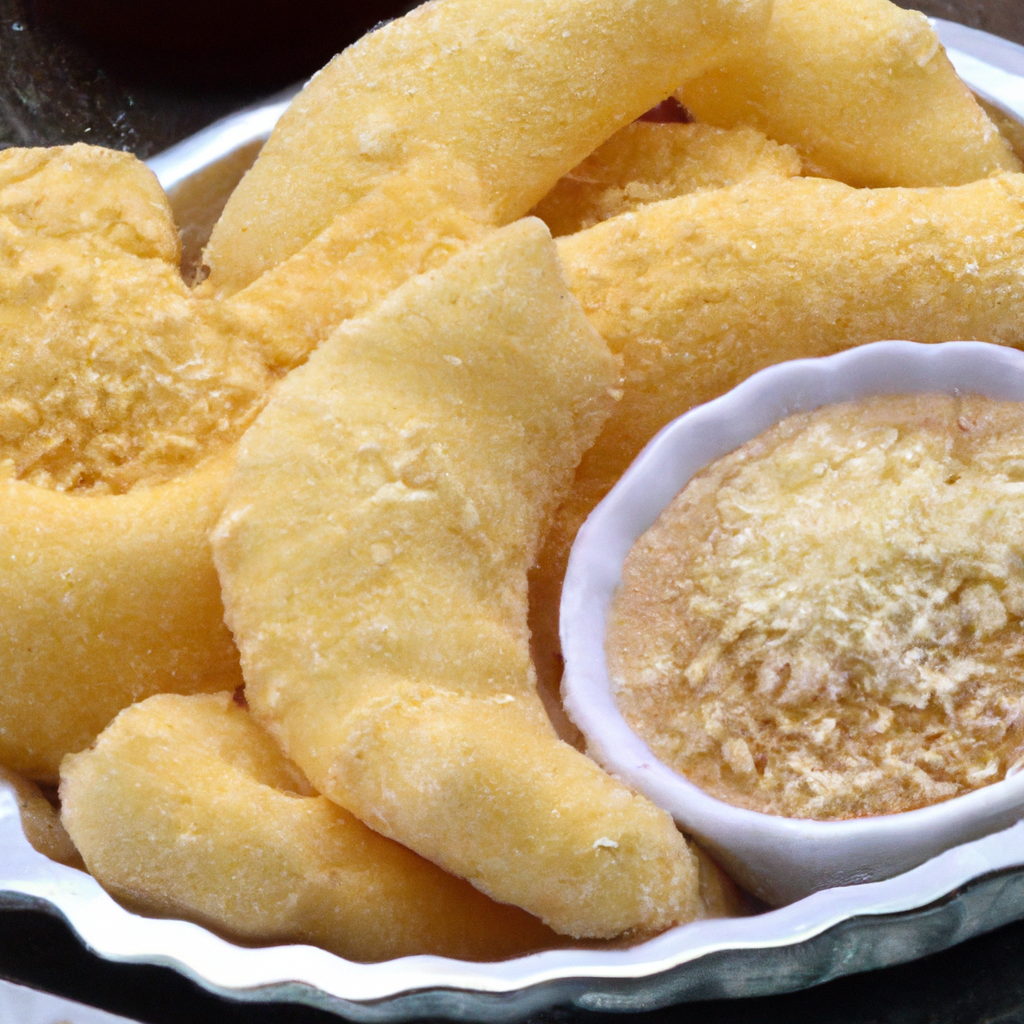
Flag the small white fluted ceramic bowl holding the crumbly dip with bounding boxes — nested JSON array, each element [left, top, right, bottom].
[[561, 341, 1024, 905]]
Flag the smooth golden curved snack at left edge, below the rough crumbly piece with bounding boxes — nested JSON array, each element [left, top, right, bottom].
[[0, 456, 242, 781]]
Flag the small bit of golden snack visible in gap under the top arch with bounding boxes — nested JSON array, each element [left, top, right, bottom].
[[531, 121, 801, 238]]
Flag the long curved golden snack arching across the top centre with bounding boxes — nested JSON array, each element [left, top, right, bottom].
[[205, 0, 769, 294]]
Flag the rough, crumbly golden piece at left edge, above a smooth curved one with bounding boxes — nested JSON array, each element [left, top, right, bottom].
[[0, 145, 268, 494]]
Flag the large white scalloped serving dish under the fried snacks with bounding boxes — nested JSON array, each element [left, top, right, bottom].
[[6, 22, 1024, 1021]]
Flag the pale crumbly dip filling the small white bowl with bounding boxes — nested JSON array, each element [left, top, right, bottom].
[[606, 395, 1024, 819]]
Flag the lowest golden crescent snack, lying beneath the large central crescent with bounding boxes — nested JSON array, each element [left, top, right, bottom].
[[60, 693, 562, 961]]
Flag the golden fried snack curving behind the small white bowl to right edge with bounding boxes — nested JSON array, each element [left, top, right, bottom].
[[530, 174, 1024, 696]]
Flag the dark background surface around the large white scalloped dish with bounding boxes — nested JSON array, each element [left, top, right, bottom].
[[0, 0, 1024, 1024]]
